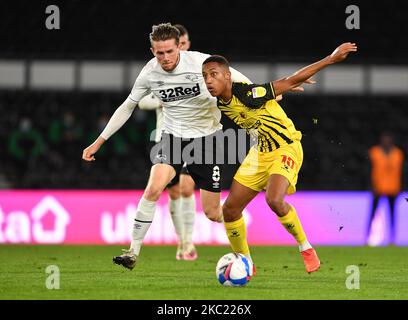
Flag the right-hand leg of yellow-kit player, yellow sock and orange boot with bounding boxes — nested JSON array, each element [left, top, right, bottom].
[[266, 174, 320, 272]]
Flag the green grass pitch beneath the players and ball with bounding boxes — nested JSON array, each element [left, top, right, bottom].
[[0, 245, 408, 300]]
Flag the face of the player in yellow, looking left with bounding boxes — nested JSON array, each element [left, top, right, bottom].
[[203, 62, 231, 97]]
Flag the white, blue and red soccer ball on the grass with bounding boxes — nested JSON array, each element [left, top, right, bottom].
[[215, 253, 252, 287]]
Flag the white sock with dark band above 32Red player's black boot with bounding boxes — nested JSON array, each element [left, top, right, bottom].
[[130, 197, 156, 255]]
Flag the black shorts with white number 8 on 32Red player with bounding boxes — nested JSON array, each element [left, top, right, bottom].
[[152, 131, 224, 192]]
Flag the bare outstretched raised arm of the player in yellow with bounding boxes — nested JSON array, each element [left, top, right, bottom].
[[272, 42, 357, 96]]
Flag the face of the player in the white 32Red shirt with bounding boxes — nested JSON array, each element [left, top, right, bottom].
[[151, 39, 180, 71]]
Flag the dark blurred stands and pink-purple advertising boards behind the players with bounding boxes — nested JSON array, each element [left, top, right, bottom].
[[0, 0, 408, 245]]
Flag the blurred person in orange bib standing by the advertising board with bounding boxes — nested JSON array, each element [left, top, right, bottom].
[[366, 132, 404, 243]]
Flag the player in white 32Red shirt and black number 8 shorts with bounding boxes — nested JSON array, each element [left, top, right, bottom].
[[82, 23, 250, 270]]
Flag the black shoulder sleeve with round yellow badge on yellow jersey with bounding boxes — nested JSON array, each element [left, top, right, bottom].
[[232, 82, 275, 109]]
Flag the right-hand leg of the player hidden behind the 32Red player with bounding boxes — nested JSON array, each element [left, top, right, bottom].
[[180, 167, 198, 260]]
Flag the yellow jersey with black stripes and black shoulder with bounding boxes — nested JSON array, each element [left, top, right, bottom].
[[217, 82, 302, 152]]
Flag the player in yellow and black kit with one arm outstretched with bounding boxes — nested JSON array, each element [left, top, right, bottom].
[[203, 43, 357, 274]]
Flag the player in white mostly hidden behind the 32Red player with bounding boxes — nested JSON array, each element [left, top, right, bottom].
[[138, 24, 198, 261]]
